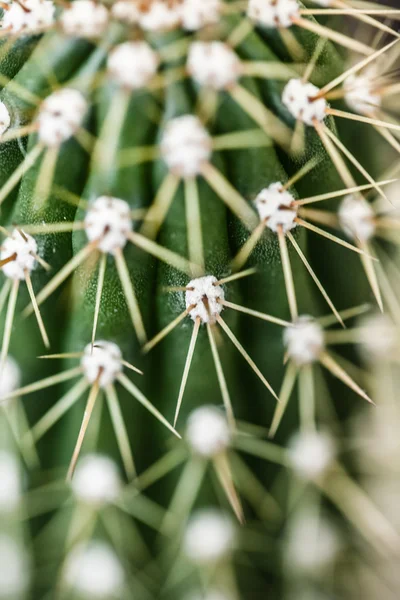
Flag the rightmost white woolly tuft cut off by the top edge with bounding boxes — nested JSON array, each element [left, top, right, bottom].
[[247, 0, 300, 29]]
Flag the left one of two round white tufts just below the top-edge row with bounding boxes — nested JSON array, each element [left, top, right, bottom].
[[107, 42, 160, 90]]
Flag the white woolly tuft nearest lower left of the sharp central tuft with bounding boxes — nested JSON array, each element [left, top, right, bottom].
[[81, 340, 122, 388]]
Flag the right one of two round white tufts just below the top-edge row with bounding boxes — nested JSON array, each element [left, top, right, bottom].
[[187, 42, 242, 90]]
